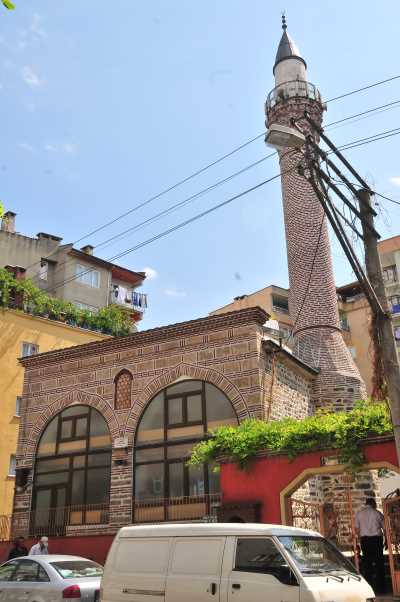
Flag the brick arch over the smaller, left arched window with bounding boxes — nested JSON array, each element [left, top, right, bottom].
[[23, 390, 120, 464]]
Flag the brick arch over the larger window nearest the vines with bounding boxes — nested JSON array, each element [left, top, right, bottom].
[[124, 363, 250, 444]]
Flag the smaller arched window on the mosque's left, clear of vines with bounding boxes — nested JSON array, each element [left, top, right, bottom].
[[33, 405, 111, 534]]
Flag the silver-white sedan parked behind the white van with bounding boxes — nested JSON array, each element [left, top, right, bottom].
[[0, 554, 103, 602]]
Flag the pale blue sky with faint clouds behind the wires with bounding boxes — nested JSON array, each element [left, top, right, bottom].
[[0, 0, 400, 328]]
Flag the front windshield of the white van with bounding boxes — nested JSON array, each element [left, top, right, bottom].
[[278, 535, 357, 575]]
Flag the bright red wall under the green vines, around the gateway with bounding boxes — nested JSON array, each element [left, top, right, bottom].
[[221, 441, 399, 523]]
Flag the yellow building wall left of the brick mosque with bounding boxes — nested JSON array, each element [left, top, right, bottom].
[[0, 309, 107, 516]]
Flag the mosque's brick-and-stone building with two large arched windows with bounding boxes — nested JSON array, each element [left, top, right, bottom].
[[13, 308, 317, 535]]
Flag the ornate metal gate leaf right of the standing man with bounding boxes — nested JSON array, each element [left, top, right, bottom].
[[383, 490, 400, 596]]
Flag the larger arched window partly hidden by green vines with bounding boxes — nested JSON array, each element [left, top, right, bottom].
[[134, 380, 238, 520]]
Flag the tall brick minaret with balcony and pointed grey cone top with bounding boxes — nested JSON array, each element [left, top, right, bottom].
[[265, 16, 366, 409]]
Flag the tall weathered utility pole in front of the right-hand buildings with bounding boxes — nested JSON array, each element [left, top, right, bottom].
[[358, 188, 400, 460]]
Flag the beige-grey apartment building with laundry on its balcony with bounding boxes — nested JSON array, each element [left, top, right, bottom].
[[0, 211, 147, 322]]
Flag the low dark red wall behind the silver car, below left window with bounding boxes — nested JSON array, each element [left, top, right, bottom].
[[0, 535, 114, 564]]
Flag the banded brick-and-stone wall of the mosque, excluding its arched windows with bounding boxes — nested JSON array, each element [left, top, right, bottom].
[[14, 308, 316, 534]]
